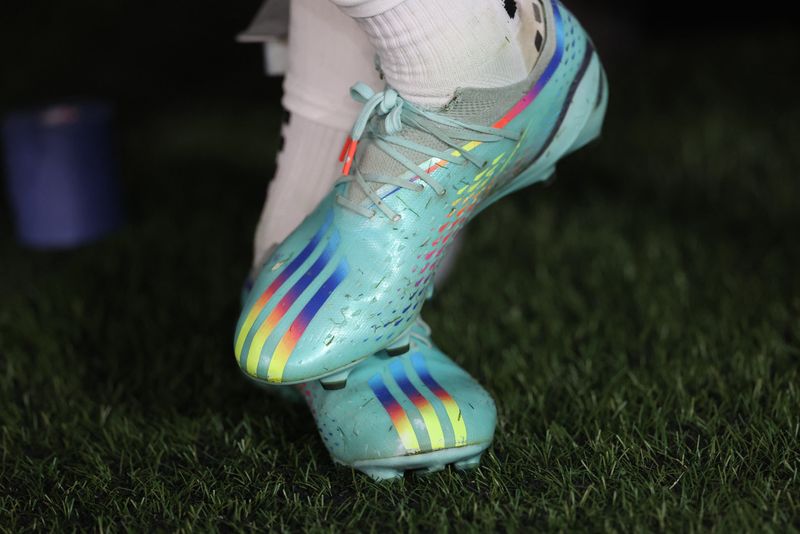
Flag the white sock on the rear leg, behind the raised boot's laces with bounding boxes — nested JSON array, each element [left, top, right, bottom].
[[253, 0, 382, 269]]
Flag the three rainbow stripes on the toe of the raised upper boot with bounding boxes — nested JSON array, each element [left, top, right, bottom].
[[235, 211, 349, 383]]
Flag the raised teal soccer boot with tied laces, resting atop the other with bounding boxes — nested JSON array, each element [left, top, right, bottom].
[[234, 0, 608, 387]]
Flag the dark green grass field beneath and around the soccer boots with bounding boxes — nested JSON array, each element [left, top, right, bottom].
[[0, 36, 800, 532]]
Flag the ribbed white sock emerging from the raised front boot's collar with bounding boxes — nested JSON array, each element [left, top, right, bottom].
[[332, 0, 541, 107]]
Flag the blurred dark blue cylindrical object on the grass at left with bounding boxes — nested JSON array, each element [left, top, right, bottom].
[[3, 102, 122, 248]]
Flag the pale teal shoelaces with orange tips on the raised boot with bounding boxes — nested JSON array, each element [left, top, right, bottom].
[[336, 82, 520, 221]]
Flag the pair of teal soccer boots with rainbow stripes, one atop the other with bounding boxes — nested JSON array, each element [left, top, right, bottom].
[[234, 0, 608, 479]]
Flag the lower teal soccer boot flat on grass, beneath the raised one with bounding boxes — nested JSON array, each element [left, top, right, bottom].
[[301, 320, 497, 480]]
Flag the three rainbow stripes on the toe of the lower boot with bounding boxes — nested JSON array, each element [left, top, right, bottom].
[[369, 352, 467, 454]]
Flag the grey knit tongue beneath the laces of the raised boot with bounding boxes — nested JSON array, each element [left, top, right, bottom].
[[347, 82, 526, 203]]
